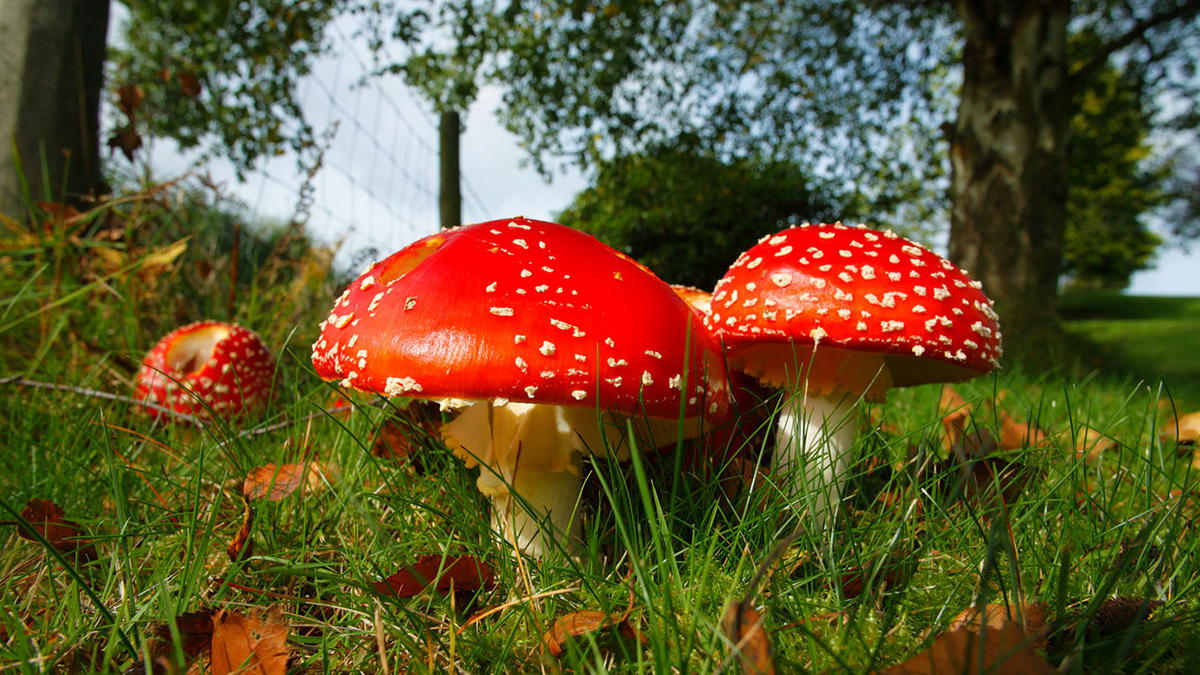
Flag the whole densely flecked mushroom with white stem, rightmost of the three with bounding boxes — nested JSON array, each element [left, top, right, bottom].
[[706, 223, 1001, 528]]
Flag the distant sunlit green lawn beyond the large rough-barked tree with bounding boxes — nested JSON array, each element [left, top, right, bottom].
[[1060, 292, 1200, 396]]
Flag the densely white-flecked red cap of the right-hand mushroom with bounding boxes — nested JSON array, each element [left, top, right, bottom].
[[706, 223, 1001, 386]]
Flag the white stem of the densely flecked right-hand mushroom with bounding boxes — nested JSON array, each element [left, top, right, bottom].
[[772, 387, 858, 532]]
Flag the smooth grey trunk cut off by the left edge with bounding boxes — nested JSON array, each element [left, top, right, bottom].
[[0, 0, 109, 216]]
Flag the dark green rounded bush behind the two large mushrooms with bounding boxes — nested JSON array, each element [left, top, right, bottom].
[[559, 149, 842, 289]]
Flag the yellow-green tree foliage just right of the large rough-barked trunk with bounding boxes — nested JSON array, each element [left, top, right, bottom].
[[1063, 48, 1170, 288]]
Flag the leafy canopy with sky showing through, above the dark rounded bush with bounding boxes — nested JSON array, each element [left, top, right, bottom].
[[491, 0, 954, 227]]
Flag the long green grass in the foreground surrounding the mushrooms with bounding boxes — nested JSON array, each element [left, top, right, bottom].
[[7, 194, 1200, 673]]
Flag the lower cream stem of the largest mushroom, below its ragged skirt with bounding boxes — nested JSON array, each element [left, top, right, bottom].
[[476, 467, 583, 557]]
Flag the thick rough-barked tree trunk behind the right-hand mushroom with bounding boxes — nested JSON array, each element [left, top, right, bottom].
[[949, 0, 1070, 356]]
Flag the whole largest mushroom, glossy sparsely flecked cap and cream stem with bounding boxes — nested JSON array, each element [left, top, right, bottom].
[[312, 217, 728, 555]]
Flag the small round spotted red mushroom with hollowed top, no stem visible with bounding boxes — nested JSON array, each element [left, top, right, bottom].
[[134, 321, 275, 419]]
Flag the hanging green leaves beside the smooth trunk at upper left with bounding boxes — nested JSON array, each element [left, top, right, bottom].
[[109, 0, 389, 171]]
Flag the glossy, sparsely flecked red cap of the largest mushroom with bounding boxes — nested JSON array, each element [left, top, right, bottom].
[[312, 217, 728, 418]]
